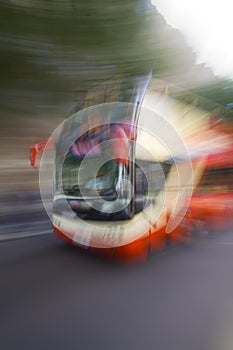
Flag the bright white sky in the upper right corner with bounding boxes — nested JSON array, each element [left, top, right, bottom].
[[151, 0, 233, 79]]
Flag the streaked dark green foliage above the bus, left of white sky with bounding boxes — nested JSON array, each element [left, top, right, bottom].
[[0, 0, 203, 112]]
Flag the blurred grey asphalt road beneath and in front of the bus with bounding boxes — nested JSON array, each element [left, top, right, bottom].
[[0, 227, 233, 350]]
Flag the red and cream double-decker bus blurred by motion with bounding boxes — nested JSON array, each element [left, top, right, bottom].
[[31, 87, 233, 260]]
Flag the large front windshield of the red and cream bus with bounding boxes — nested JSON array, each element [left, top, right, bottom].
[[54, 123, 134, 220]]
